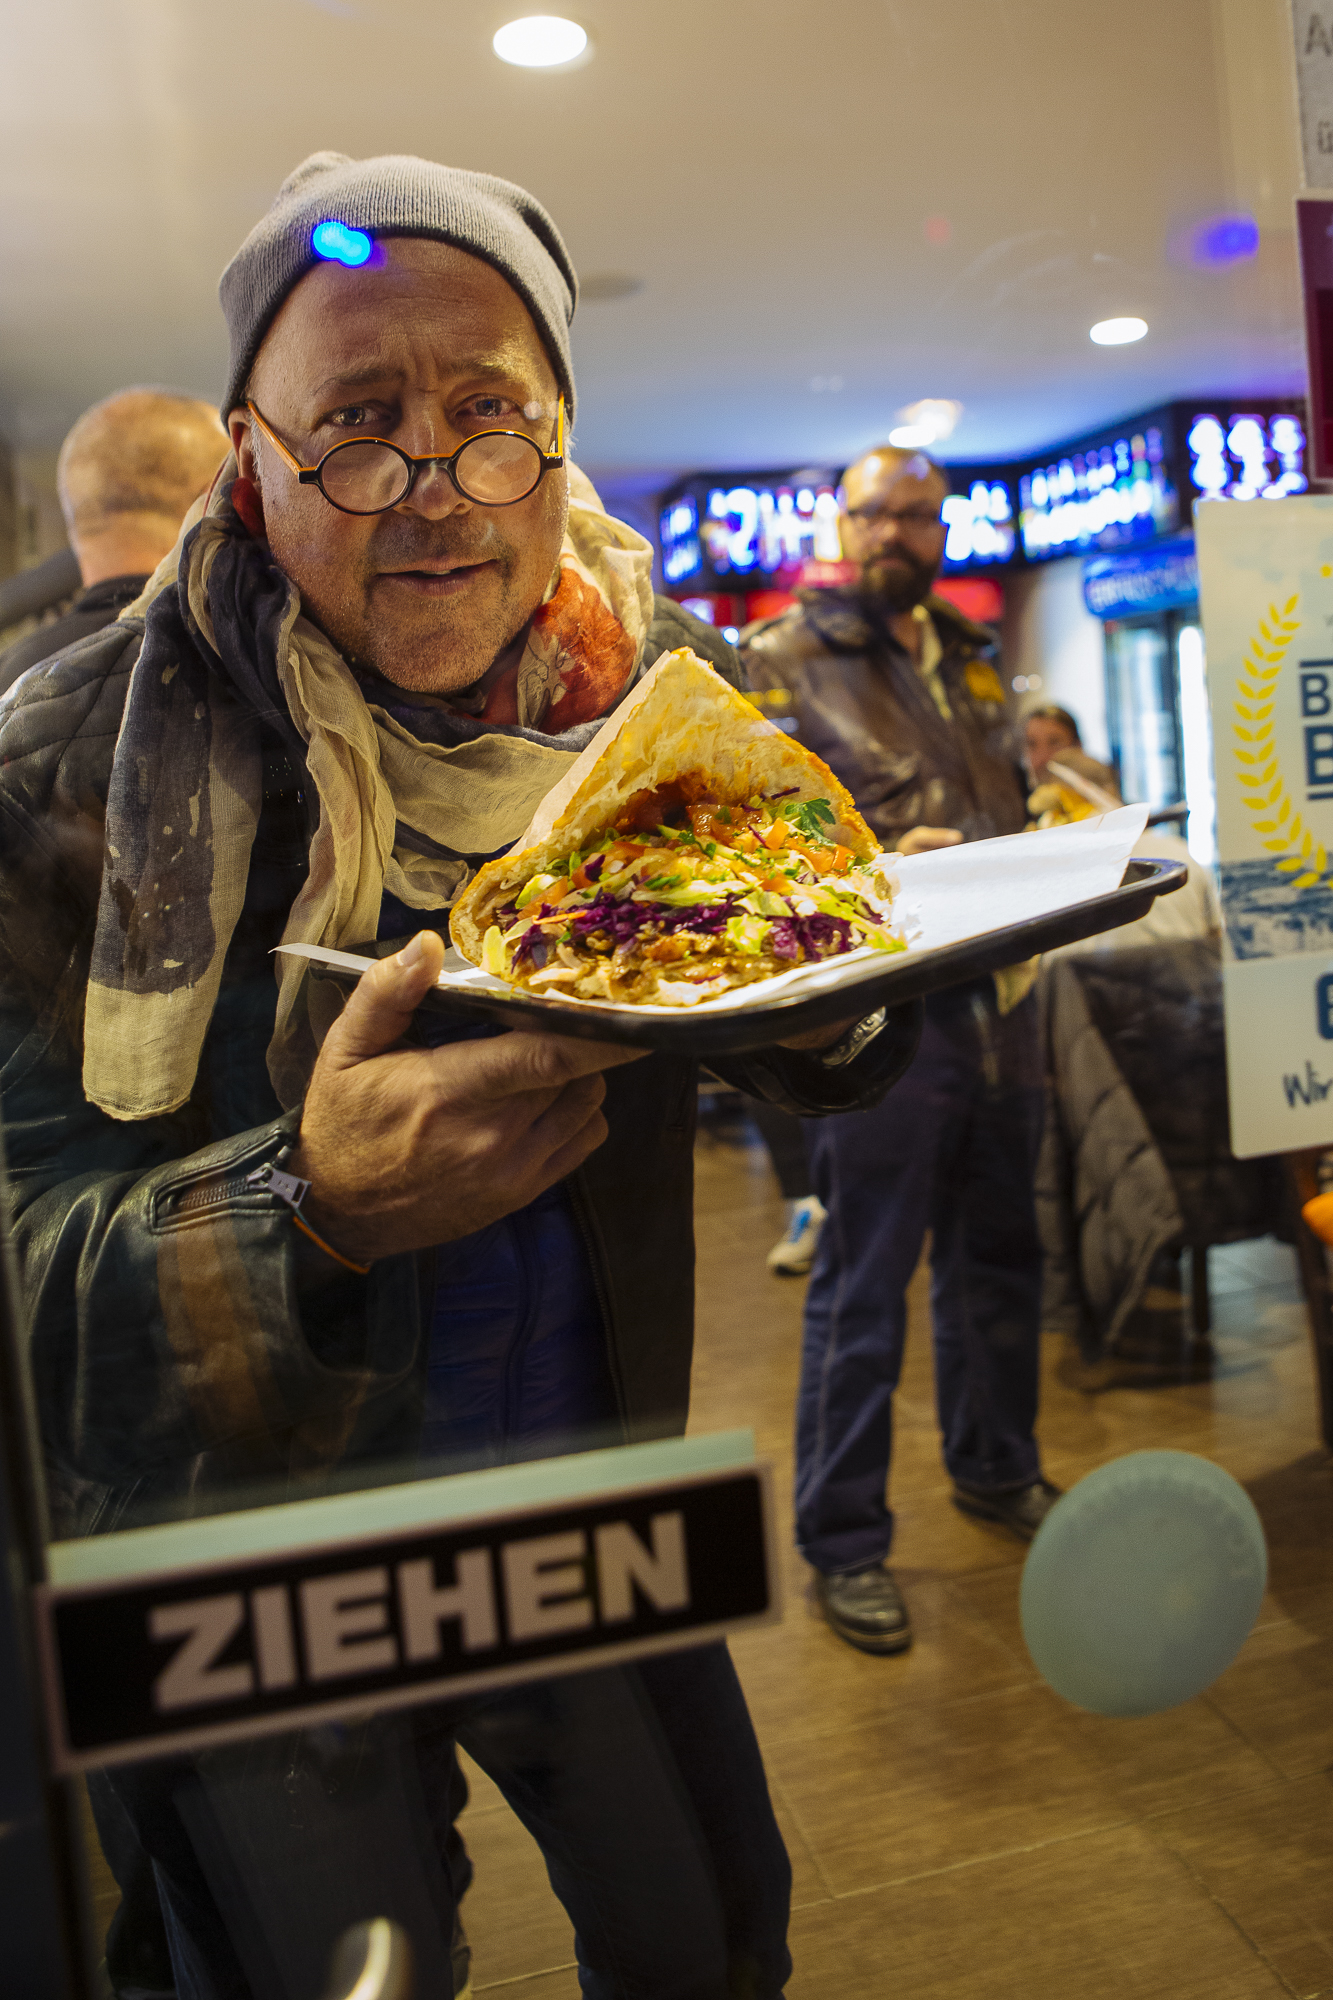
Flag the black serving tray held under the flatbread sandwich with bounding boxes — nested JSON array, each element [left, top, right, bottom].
[[300, 856, 1187, 1060]]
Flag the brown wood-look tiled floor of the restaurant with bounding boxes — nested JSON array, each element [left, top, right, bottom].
[[78, 1124, 1333, 2000]]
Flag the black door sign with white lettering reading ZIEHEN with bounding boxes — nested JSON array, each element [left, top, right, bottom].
[[38, 1464, 779, 1770]]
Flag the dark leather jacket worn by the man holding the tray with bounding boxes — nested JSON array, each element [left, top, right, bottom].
[[0, 602, 911, 1534]]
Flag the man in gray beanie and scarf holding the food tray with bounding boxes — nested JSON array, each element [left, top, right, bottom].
[[0, 154, 901, 2000]]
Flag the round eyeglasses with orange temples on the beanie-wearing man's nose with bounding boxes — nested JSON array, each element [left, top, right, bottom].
[[246, 396, 564, 514]]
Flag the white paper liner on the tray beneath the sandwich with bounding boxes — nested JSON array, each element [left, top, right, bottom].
[[278, 806, 1149, 1020]]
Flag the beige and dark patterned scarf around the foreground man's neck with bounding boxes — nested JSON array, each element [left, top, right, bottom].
[[84, 460, 652, 1118]]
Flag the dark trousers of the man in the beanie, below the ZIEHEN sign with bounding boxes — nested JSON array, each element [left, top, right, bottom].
[[106, 1644, 791, 2000]]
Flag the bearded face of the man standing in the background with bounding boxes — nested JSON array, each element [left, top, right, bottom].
[[841, 452, 949, 612]]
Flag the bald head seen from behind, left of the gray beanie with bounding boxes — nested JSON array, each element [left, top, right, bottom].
[[56, 388, 228, 584]]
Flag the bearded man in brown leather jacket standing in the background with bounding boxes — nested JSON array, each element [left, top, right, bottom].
[[741, 446, 1055, 1654]]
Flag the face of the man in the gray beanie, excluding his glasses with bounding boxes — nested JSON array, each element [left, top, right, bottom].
[[230, 236, 568, 694]]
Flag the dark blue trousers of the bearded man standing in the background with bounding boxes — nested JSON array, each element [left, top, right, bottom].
[[797, 980, 1043, 1576]]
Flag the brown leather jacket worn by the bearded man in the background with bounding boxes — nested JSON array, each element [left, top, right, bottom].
[[741, 590, 1027, 848]]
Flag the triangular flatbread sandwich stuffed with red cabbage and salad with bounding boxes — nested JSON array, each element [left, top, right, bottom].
[[450, 650, 905, 1006]]
